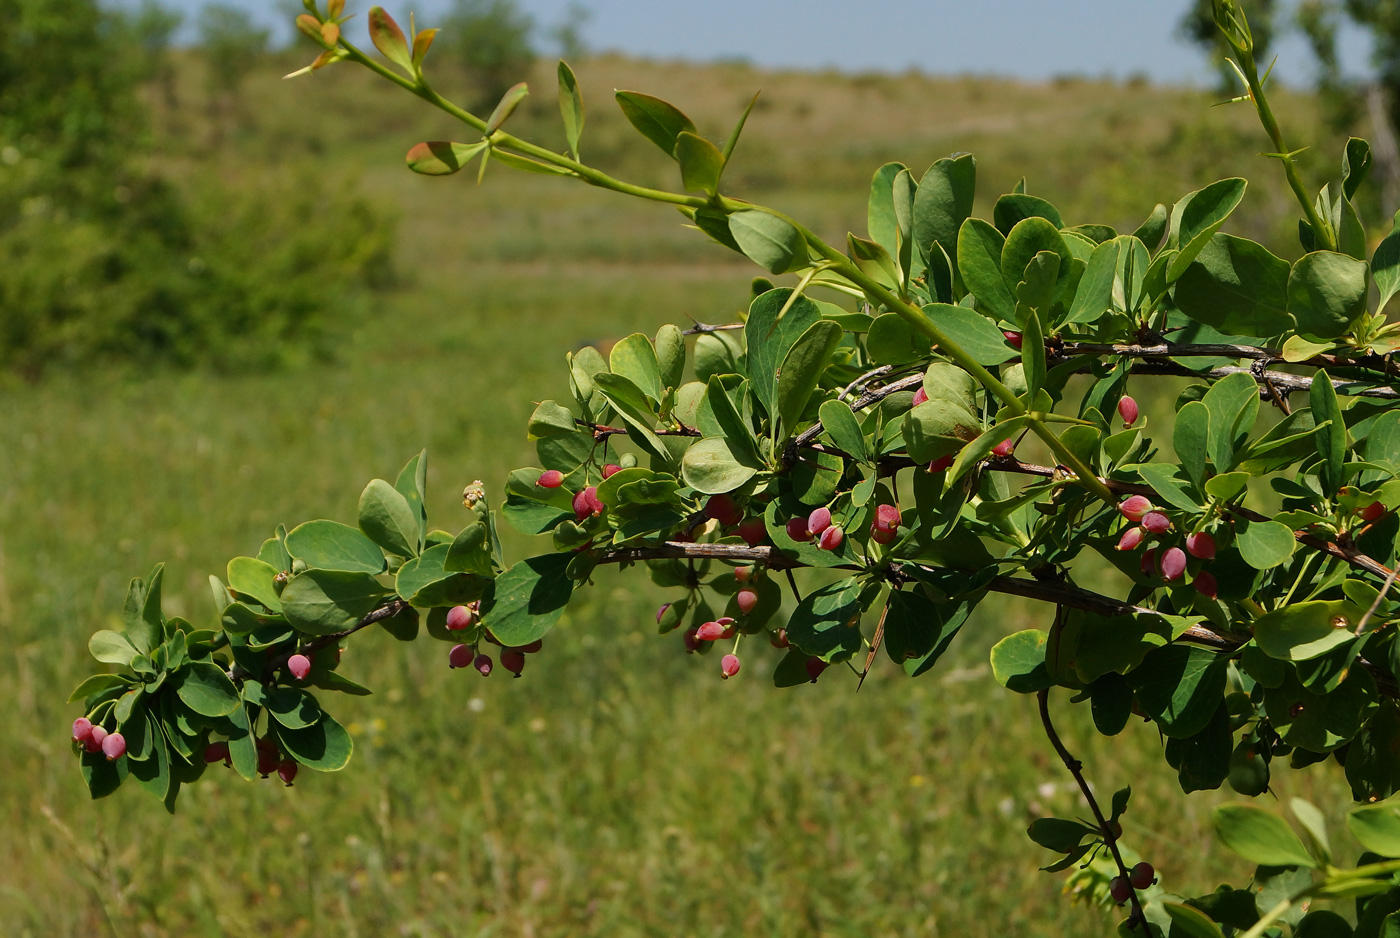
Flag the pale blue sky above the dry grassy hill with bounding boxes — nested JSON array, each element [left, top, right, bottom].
[[153, 0, 1369, 84]]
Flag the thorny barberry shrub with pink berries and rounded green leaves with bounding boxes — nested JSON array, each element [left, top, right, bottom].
[[71, 0, 1400, 938]]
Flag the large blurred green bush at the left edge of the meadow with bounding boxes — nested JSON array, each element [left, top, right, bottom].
[[0, 0, 391, 379]]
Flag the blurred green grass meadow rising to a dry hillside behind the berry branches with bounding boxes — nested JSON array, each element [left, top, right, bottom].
[[0, 47, 1377, 938]]
